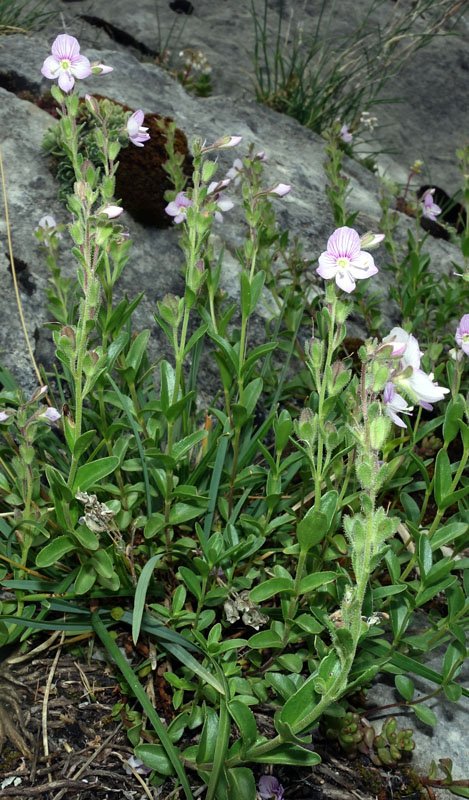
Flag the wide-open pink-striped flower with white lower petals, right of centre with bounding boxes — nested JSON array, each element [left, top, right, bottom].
[[316, 226, 378, 293]]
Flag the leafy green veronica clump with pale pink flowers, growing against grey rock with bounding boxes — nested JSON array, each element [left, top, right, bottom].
[[0, 28, 469, 800]]
